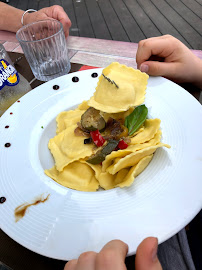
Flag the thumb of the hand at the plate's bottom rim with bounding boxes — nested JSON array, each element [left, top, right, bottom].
[[135, 237, 162, 270]]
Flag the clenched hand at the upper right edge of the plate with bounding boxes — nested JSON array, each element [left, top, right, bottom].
[[136, 35, 202, 85]]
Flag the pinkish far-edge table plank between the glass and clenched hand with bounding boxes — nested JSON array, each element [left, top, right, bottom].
[[67, 36, 138, 58]]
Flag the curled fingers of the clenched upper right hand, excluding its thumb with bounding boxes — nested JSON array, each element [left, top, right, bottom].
[[136, 35, 175, 68]]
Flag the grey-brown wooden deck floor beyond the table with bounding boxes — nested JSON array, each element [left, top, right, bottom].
[[5, 0, 202, 50]]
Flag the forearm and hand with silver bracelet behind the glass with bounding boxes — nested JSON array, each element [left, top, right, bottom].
[[0, 2, 71, 37]]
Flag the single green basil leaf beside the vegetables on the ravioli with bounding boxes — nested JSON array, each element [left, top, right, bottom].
[[124, 105, 148, 135]]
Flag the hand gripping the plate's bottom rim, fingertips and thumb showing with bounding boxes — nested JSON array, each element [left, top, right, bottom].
[[64, 237, 162, 270]]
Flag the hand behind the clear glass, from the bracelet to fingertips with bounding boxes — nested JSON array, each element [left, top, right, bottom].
[[24, 5, 71, 37]]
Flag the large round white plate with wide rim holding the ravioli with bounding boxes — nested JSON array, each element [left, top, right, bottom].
[[0, 69, 202, 260]]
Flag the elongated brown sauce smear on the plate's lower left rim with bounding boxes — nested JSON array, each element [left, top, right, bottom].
[[14, 194, 50, 222]]
